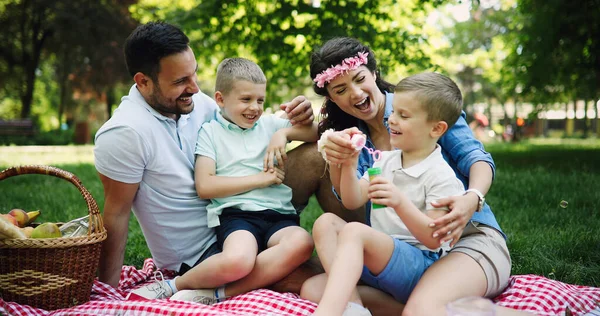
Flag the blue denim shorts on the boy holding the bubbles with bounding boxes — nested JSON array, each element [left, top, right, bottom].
[[360, 238, 440, 303]]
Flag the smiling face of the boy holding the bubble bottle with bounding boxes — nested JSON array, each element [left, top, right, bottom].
[[388, 92, 439, 152]]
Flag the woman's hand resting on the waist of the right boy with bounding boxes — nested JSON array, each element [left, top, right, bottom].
[[430, 194, 479, 247]]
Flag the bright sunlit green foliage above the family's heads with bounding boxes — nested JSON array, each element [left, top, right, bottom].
[[146, 0, 431, 104]]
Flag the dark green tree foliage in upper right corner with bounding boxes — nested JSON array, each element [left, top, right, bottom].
[[514, 0, 600, 100]]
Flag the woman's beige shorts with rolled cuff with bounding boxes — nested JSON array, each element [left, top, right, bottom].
[[450, 222, 511, 298]]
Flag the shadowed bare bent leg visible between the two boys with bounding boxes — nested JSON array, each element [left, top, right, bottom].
[[283, 143, 365, 223]]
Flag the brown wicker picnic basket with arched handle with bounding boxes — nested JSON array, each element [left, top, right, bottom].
[[0, 166, 106, 310]]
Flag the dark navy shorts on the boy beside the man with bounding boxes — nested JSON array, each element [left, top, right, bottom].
[[215, 208, 300, 252]]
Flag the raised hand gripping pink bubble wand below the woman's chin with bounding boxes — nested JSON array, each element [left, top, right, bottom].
[[319, 127, 362, 165]]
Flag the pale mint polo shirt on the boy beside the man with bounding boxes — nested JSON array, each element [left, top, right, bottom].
[[196, 112, 296, 227]]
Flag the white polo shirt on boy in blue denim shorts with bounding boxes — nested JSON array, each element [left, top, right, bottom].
[[363, 145, 464, 251]]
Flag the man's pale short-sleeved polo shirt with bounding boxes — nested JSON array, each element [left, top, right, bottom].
[[94, 85, 217, 271]]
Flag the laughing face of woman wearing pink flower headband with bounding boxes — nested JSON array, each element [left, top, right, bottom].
[[327, 66, 385, 121]]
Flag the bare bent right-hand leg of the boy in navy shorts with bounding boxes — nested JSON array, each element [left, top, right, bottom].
[[225, 226, 314, 296]]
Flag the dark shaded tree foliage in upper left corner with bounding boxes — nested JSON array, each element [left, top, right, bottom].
[[0, 0, 135, 117]]
